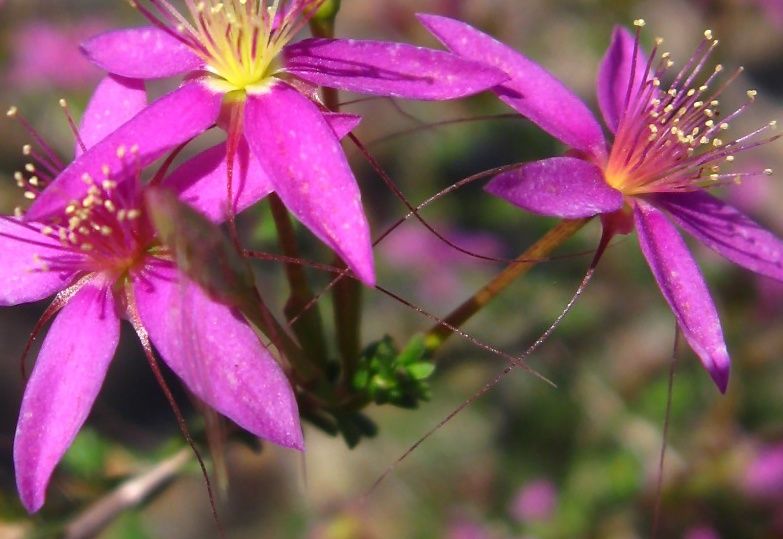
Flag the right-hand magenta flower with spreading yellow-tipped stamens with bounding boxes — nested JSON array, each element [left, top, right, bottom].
[[421, 15, 783, 391]]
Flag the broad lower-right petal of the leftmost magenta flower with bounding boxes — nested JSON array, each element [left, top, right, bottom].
[[134, 265, 303, 449]]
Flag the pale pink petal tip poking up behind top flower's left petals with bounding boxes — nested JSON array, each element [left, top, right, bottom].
[[75, 75, 147, 157]]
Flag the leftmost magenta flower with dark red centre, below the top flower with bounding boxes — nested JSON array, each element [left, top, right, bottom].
[[0, 78, 303, 512]]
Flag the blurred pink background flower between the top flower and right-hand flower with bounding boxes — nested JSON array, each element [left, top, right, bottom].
[[380, 223, 502, 301]]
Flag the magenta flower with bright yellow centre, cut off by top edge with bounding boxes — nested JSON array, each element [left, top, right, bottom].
[[29, 0, 507, 284]]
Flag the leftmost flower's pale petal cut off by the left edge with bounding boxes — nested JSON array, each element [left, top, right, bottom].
[[0, 216, 82, 306]]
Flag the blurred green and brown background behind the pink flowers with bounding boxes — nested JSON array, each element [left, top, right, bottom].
[[0, 0, 783, 539]]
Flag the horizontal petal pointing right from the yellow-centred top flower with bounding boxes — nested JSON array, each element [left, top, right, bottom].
[[285, 38, 508, 100]]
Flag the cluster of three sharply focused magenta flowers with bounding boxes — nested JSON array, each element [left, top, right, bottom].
[[0, 0, 783, 519]]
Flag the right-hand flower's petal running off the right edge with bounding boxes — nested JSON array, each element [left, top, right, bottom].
[[655, 191, 783, 281]]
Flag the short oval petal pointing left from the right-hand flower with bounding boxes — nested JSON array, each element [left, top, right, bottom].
[[485, 157, 623, 219]]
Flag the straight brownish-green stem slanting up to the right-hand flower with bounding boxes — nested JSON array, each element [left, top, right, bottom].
[[424, 218, 591, 353]]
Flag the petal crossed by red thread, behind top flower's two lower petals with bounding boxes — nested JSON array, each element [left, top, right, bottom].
[[164, 137, 272, 223]]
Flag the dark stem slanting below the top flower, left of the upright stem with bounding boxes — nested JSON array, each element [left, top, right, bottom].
[[269, 193, 327, 366]]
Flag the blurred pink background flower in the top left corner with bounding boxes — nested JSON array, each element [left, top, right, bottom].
[[0, 19, 109, 90]]
